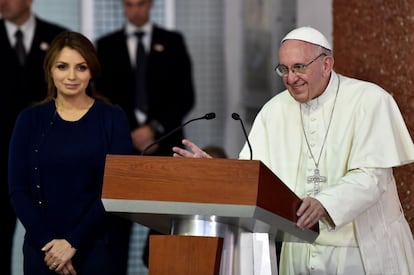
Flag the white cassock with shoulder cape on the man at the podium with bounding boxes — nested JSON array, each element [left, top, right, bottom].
[[240, 72, 414, 275]]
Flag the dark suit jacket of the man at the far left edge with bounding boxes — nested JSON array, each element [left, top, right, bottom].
[[0, 18, 65, 166]]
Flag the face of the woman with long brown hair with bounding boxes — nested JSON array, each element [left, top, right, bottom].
[[51, 47, 92, 96]]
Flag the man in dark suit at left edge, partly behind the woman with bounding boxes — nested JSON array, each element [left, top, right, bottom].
[[0, 0, 64, 274]]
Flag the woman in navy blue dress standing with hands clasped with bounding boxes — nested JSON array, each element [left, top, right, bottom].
[[9, 32, 132, 275]]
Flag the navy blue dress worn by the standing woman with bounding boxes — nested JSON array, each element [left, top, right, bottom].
[[9, 100, 133, 275]]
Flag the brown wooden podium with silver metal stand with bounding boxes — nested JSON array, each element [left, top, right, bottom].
[[102, 155, 319, 275]]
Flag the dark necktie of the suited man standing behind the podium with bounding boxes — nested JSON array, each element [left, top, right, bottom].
[[135, 32, 148, 113]]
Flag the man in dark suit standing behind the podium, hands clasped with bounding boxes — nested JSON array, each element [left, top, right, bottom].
[[96, 0, 195, 266]]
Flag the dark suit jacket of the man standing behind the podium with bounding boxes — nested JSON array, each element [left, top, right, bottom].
[[96, 26, 195, 156]]
